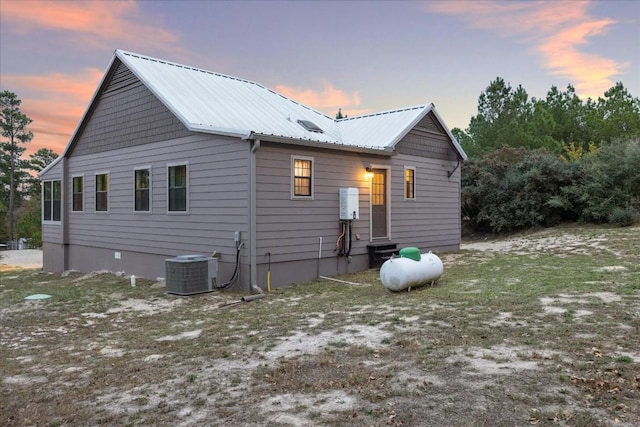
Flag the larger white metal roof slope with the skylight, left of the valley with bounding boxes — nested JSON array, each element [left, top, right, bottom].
[[116, 51, 340, 143]]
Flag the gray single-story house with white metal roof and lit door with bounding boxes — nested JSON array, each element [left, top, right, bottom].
[[40, 50, 466, 291]]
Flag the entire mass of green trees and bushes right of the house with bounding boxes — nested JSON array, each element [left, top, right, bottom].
[[452, 77, 640, 233]]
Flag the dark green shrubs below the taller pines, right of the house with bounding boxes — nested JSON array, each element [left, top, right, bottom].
[[461, 140, 640, 233]]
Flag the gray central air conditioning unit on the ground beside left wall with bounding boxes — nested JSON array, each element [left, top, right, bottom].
[[165, 255, 218, 295]]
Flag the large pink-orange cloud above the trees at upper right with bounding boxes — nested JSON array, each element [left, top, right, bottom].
[[423, 1, 626, 97]]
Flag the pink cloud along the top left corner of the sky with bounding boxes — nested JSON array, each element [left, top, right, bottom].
[[2, 0, 178, 50]]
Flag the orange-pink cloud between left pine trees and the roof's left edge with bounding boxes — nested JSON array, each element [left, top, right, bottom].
[[2, 68, 102, 154]]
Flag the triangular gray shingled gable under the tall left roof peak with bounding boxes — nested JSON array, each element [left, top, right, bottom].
[[72, 63, 190, 156]]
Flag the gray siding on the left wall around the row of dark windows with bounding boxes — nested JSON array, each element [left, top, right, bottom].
[[65, 134, 249, 277]]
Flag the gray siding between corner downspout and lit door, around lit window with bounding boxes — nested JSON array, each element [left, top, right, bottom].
[[256, 143, 377, 263]]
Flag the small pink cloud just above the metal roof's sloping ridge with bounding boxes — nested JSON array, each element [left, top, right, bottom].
[[275, 82, 364, 116]]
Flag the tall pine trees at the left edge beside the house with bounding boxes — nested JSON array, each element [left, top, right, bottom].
[[0, 91, 58, 246]]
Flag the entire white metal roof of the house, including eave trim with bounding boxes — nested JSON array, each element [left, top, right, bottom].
[[40, 50, 467, 175]]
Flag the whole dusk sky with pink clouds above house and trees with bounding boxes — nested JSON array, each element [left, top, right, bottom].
[[0, 0, 640, 157]]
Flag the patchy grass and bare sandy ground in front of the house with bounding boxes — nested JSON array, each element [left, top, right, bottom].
[[0, 226, 640, 426]]
